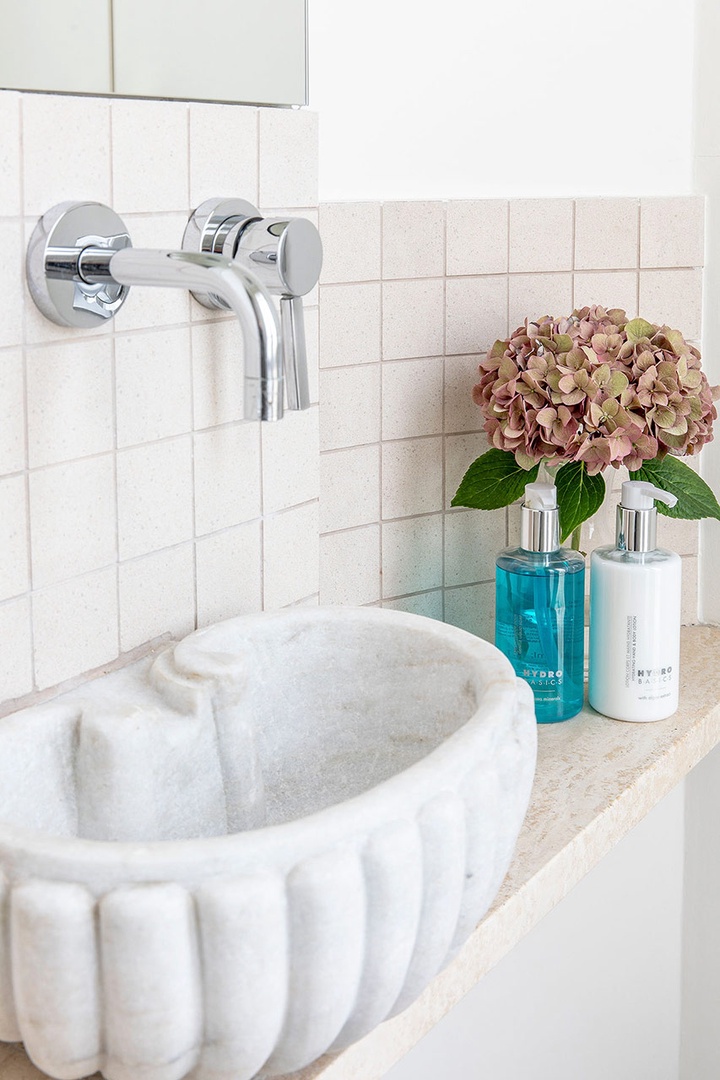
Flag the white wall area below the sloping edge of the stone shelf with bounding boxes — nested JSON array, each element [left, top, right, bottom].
[[386, 788, 686, 1080]]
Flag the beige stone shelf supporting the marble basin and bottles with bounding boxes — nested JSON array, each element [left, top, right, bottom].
[[0, 626, 720, 1080]]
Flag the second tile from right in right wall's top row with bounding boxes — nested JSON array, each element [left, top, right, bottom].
[[575, 199, 639, 270]]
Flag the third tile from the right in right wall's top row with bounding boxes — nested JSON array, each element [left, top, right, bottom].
[[510, 199, 573, 273]]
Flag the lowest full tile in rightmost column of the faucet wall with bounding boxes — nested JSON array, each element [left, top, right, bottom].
[[262, 502, 320, 611]]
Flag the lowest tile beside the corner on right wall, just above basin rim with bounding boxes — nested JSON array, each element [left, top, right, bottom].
[[320, 525, 380, 605]]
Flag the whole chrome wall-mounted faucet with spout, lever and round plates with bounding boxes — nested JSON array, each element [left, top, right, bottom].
[[27, 200, 323, 420]]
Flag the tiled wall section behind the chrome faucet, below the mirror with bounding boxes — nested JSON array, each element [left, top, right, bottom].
[[0, 92, 318, 701]]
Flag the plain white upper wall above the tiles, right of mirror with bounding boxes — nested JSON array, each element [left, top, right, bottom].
[[310, 0, 694, 201]]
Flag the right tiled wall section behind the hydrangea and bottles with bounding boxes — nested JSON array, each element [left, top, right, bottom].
[[320, 198, 704, 637]]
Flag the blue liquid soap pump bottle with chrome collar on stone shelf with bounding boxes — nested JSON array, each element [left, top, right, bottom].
[[495, 484, 585, 724]]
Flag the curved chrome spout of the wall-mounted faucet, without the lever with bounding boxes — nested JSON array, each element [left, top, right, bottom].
[[88, 247, 284, 420]]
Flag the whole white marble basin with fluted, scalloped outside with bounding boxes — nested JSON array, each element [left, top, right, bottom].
[[0, 608, 535, 1080]]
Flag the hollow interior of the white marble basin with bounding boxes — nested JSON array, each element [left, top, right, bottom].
[[0, 616, 496, 840]]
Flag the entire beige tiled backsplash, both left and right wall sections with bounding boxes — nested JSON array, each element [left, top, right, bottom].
[[0, 92, 703, 707]]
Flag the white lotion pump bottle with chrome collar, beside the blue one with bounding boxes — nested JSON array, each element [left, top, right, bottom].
[[589, 481, 681, 723]]
